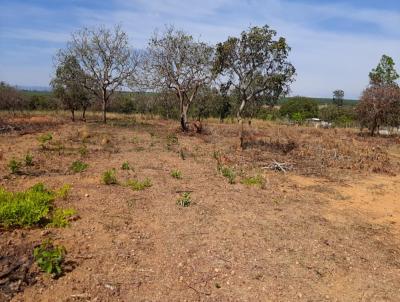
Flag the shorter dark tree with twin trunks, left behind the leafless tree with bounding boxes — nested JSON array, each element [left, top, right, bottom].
[[50, 56, 90, 121]]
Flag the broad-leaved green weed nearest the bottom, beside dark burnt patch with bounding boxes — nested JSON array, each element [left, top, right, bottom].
[[33, 240, 66, 278]]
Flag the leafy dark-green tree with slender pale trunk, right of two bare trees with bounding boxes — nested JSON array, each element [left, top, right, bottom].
[[214, 25, 295, 147]]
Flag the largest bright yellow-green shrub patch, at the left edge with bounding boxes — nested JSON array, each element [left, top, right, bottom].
[[0, 183, 55, 228]]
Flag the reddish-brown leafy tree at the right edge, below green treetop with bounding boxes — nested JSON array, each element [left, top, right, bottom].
[[356, 85, 400, 136]]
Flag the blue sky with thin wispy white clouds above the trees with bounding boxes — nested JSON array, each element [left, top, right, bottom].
[[0, 0, 400, 98]]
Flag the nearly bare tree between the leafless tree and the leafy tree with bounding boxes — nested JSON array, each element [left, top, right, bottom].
[[144, 27, 213, 131]]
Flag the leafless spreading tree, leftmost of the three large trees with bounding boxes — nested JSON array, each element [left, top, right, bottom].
[[57, 26, 138, 123]]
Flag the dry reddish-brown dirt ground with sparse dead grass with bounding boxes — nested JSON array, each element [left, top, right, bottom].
[[0, 116, 400, 301]]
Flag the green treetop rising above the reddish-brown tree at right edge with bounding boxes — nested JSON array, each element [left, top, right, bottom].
[[369, 55, 400, 86]]
